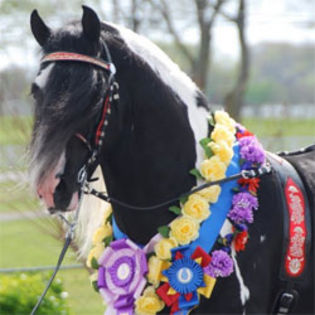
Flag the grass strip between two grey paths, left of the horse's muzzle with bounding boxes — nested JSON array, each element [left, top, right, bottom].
[[0, 180, 40, 212]]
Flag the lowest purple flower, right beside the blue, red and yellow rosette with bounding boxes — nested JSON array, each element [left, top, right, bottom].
[[204, 250, 233, 278]]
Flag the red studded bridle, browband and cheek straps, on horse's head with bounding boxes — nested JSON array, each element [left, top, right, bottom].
[[41, 43, 119, 183]]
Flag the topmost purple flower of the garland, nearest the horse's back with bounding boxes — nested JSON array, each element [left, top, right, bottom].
[[239, 136, 266, 164]]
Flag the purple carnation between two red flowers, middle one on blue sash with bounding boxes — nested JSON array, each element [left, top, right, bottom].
[[228, 192, 258, 223]]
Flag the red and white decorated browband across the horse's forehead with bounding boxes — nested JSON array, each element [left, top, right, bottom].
[[42, 51, 114, 72]]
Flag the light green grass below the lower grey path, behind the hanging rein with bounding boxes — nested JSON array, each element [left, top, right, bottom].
[[0, 219, 104, 315]]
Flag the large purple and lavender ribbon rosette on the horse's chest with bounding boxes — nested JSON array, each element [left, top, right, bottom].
[[97, 239, 148, 315]]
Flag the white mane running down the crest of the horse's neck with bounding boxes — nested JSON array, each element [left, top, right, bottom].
[[107, 22, 208, 167]]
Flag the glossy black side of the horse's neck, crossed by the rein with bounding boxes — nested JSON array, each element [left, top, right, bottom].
[[101, 57, 202, 243]]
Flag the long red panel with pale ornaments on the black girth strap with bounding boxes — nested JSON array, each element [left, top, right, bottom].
[[285, 178, 306, 277]]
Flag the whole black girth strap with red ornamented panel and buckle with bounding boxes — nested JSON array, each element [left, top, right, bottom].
[[268, 153, 311, 315]]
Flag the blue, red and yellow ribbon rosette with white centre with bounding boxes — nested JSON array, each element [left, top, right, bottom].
[[156, 245, 216, 315]]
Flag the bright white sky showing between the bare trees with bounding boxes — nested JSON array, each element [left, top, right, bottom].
[[0, 0, 315, 70]]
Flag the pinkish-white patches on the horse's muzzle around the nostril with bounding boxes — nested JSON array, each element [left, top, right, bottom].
[[37, 153, 79, 211]]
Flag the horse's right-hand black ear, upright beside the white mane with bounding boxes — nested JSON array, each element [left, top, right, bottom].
[[82, 5, 101, 42]]
